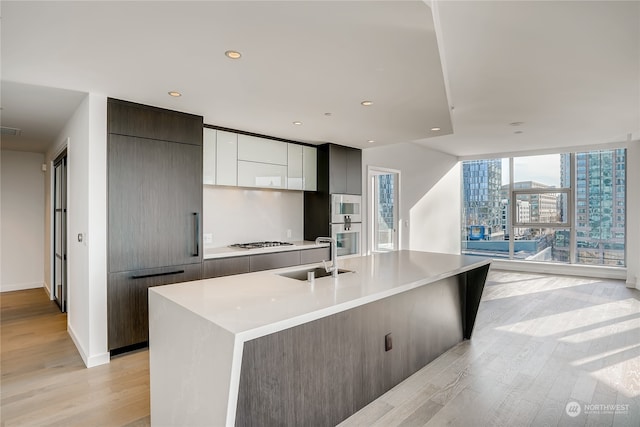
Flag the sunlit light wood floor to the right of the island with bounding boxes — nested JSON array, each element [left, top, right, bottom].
[[341, 271, 640, 427]]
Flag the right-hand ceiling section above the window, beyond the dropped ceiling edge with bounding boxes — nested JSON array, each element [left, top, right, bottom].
[[424, 1, 640, 156]]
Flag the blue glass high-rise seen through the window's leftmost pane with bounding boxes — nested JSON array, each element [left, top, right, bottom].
[[462, 159, 503, 239]]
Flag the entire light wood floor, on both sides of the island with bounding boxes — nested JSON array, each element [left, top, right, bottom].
[[0, 271, 640, 427]]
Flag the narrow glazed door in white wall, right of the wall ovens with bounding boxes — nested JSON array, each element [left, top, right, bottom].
[[369, 167, 400, 252]]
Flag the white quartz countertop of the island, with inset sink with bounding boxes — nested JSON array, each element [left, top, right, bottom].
[[149, 251, 490, 341]]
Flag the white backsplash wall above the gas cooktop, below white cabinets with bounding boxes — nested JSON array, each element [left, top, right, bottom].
[[202, 185, 304, 248]]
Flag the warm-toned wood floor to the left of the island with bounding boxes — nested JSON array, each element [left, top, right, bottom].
[[0, 288, 150, 427]]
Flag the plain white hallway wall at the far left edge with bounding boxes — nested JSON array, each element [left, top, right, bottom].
[[0, 150, 45, 292]]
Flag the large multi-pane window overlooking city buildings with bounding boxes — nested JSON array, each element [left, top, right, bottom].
[[461, 149, 626, 266]]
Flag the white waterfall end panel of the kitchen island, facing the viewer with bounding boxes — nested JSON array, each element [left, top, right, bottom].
[[149, 290, 240, 426]]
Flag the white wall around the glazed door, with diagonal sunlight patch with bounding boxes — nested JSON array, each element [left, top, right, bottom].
[[362, 143, 460, 254]]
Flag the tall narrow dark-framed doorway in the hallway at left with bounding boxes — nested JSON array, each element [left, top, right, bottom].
[[53, 150, 67, 313]]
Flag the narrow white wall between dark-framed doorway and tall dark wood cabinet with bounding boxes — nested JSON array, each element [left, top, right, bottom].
[[46, 94, 109, 367]]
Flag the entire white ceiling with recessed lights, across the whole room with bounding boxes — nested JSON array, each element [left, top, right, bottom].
[[1, 0, 640, 156]]
